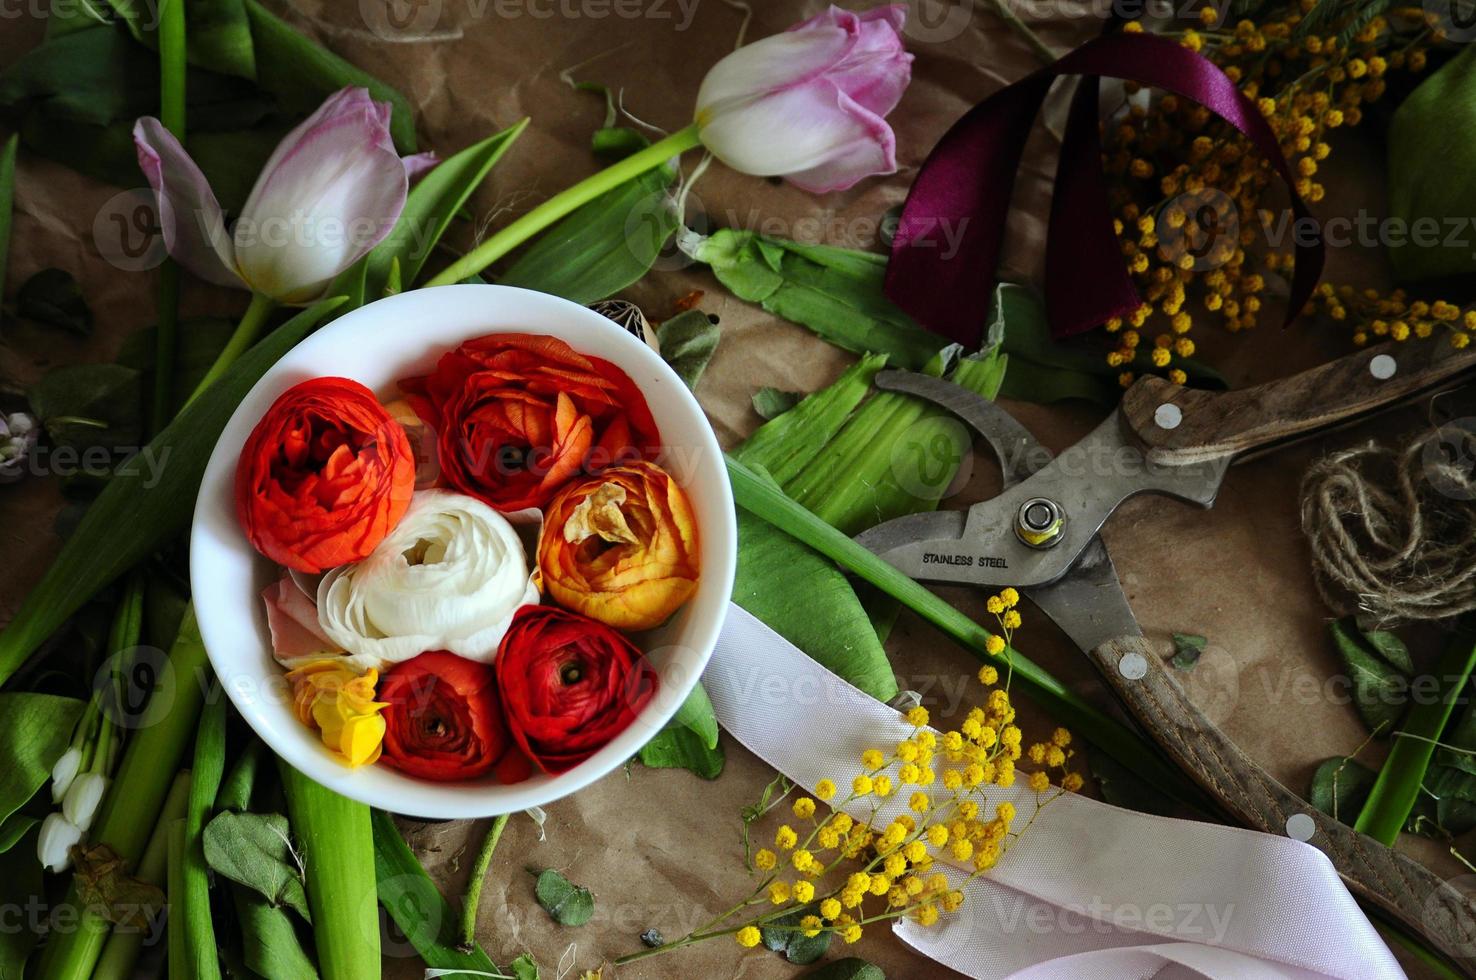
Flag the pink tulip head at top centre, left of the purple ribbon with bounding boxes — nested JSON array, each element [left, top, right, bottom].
[[697, 4, 912, 193]]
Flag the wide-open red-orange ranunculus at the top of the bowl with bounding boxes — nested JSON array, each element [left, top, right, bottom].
[[401, 334, 661, 511]]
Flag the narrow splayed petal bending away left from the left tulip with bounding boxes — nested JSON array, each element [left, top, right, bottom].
[[133, 117, 241, 286]]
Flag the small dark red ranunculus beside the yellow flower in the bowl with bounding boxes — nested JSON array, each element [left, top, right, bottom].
[[376, 651, 509, 781]]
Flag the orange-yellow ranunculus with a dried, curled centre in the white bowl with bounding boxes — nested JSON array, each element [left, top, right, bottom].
[[539, 460, 698, 630]]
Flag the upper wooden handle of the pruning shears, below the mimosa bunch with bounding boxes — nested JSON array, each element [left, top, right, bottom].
[[1122, 338, 1476, 466]]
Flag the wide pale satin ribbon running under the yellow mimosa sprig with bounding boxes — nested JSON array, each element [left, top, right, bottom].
[[703, 605, 1405, 980]]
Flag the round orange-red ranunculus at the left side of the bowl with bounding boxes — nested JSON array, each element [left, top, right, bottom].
[[236, 378, 415, 573]]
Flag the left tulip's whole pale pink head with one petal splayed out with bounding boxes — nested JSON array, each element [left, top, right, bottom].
[[133, 89, 434, 306]]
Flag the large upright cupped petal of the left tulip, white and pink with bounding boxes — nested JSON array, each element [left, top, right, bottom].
[[235, 89, 409, 304]]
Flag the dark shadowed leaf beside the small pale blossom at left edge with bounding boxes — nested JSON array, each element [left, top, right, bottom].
[[27, 365, 143, 449]]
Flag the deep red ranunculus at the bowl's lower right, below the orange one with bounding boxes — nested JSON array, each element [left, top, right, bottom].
[[496, 605, 657, 773]]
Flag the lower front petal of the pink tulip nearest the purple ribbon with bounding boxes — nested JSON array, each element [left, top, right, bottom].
[[701, 84, 897, 193]]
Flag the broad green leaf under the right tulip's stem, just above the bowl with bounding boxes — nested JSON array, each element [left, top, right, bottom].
[[497, 167, 679, 303]]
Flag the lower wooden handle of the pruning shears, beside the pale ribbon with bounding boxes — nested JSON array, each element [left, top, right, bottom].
[[1091, 636, 1476, 976]]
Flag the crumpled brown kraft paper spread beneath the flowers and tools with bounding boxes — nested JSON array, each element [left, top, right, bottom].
[[0, 0, 1461, 980]]
